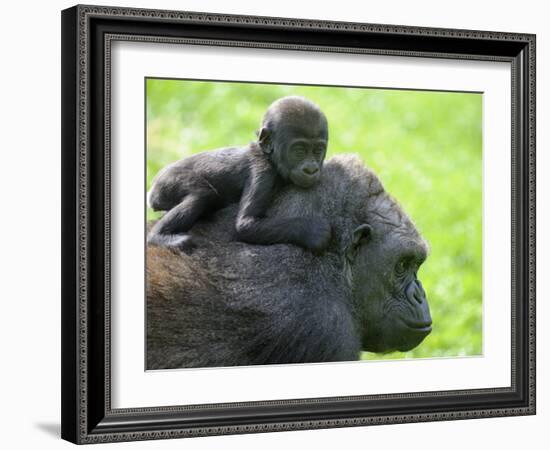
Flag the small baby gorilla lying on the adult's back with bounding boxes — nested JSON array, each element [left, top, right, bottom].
[[147, 96, 331, 252]]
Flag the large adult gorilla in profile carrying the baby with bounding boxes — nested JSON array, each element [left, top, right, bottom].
[[147, 155, 431, 369]]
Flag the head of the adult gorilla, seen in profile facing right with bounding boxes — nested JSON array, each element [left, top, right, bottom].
[[272, 155, 432, 352]]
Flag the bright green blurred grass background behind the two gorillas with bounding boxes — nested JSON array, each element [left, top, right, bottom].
[[146, 79, 482, 359]]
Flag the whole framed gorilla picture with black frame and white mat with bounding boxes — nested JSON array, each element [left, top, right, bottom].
[[62, 6, 535, 444]]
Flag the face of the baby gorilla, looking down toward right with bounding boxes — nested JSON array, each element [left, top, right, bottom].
[[284, 131, 327, 188]]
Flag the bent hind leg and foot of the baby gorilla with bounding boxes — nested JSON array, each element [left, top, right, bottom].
[[147, 191, 219, 252]]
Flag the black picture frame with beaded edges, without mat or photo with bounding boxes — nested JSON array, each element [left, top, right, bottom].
[[61, 5, 535, 444]]
